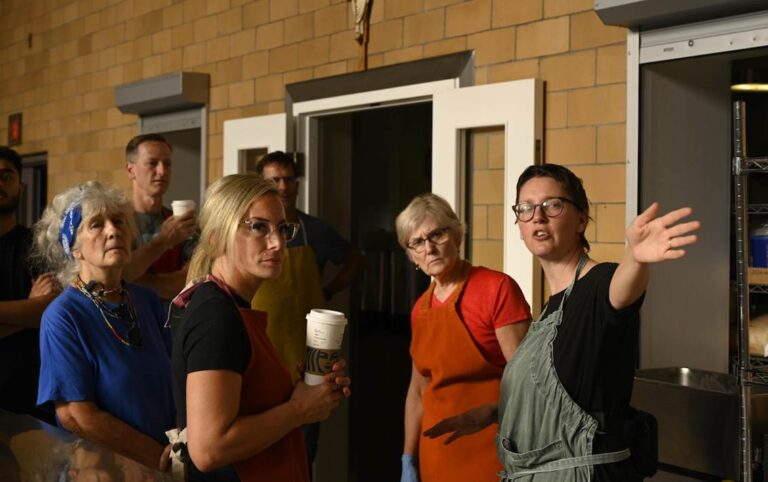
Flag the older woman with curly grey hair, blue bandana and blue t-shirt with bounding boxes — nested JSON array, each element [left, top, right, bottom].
[[35, 182, 175, 470]]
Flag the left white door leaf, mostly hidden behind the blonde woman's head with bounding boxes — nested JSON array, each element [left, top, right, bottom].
[[224, 114, 287, 176]]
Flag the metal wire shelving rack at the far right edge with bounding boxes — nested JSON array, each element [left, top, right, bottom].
[[732, 101, 768, 482]]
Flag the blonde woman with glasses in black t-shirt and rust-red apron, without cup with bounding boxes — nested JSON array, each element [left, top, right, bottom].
[[173, 174, 350, 482]]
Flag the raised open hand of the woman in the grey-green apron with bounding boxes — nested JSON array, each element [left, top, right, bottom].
[[626, 202, 701, 263]]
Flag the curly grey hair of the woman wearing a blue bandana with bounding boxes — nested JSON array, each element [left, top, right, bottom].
[[32, 181, 138, 286]]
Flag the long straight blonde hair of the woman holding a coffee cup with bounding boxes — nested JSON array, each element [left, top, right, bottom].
[[187, 173, 277, 282]]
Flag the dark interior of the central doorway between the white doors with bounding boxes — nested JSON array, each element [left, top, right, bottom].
[[316, 103, 432, 482]]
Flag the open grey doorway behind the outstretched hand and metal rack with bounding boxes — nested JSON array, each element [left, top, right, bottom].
[[638, 44, 768, 373]]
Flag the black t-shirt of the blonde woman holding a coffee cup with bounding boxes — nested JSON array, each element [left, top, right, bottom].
[[171, 283, 251, 482]]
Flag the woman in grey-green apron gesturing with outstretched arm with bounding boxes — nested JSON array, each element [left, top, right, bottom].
[[429, 164, 699, 482]]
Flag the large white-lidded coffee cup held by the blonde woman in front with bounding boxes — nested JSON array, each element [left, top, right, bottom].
[[304, 309, 347, 385]]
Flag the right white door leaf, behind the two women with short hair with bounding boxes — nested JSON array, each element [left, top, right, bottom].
[[432, 79, 544, 309]]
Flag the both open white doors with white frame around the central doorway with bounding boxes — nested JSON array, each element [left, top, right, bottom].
[[224, 79, 543, 307]]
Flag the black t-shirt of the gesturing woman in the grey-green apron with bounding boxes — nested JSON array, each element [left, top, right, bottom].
[[545, 263, 644, 482]]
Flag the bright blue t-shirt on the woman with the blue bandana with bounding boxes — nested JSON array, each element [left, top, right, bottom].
[[37, 284, 176, 445]]
